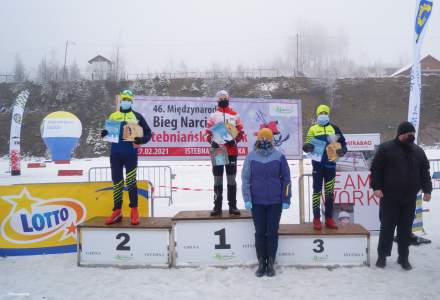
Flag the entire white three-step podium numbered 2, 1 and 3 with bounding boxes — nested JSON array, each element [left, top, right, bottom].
[[77, 210, 370, 268]]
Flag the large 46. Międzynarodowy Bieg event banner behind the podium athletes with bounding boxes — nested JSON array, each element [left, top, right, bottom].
[[134, 96, 302, 160]]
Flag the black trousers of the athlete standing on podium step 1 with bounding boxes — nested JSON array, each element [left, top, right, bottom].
[[212, 156, 237, 209]]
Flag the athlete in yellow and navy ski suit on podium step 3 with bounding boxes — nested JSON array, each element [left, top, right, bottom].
[[303, 104, 347, 230]]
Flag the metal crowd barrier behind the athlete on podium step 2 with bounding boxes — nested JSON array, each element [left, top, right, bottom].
[[89, 166, 175, 217]]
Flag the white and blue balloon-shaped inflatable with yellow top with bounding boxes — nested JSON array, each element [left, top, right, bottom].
[[40, 111, 82, 164]]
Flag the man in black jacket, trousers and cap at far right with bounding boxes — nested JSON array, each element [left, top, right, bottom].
[[371, 122, 432, 270]]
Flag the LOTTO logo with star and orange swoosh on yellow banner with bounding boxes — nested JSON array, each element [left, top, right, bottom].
[[1, 188, 86, 244]]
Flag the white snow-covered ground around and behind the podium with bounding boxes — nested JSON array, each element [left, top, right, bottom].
[[0, 149, 440, 299]]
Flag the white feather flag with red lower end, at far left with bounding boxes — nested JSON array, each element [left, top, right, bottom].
[[9, 90, 29, 176]]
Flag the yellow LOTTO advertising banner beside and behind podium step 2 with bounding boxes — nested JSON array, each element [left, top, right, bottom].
[[0, 181, 149, 256]]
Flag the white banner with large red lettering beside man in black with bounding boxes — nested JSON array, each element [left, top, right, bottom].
[[334, 171, 380, 231]]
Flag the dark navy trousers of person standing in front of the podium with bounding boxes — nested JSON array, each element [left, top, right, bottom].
[[252, 203, 281, 259]]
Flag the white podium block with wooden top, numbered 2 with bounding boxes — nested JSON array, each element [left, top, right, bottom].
[[77, 217, 171, 268]]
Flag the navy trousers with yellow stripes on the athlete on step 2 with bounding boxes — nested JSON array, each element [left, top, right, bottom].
[[110, 153, 138, 210]]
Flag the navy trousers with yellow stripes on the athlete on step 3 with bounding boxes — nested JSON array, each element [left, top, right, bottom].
[[312, 166, 336, 219]]
